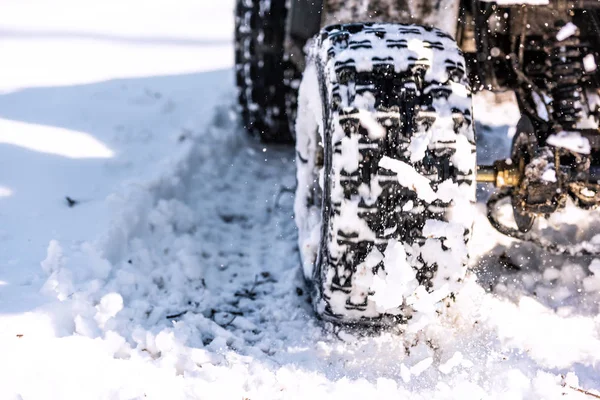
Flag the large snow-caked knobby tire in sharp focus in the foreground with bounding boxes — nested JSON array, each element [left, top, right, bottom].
[[295, 24, 476, 324]]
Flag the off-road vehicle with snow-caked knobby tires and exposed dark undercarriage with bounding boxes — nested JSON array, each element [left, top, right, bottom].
[[235, 0, 600, 325]]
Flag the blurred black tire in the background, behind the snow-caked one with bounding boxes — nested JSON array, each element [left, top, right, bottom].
[[235, 0, 299, 142]]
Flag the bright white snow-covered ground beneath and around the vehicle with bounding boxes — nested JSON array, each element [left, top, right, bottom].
[[0, 0, 600, 399]]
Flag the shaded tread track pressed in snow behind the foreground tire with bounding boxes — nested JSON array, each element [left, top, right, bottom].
[[189, 137, 314, 354]]
